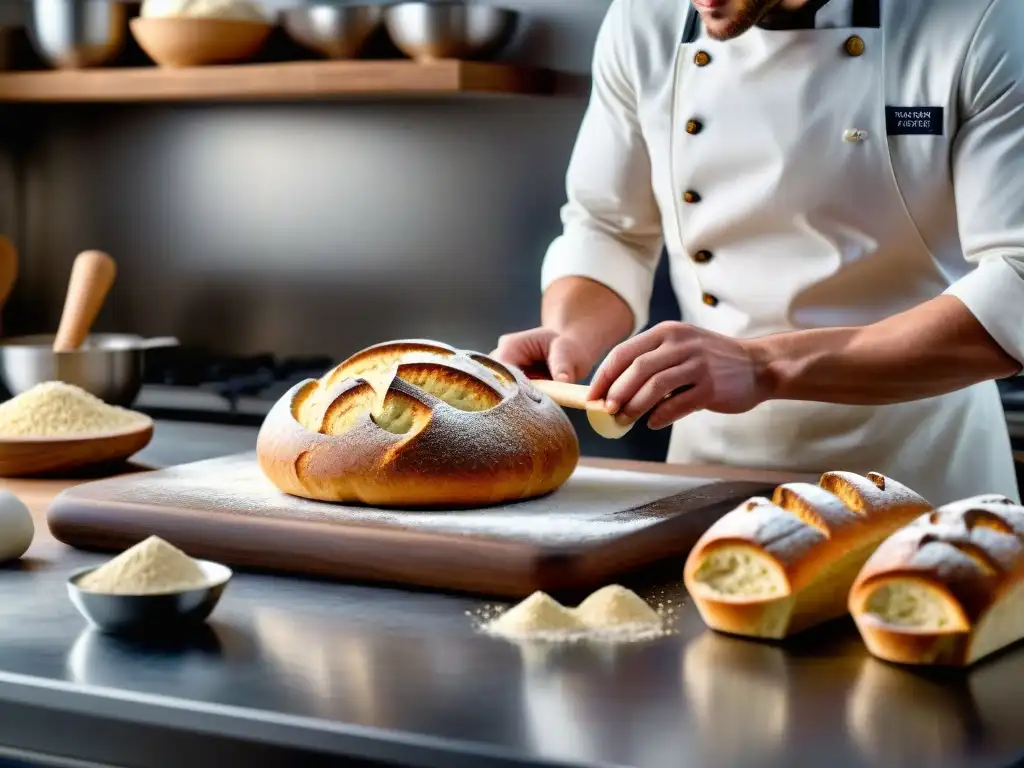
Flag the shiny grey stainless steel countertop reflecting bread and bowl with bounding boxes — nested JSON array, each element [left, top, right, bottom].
[[0, 422, 1024, 768]]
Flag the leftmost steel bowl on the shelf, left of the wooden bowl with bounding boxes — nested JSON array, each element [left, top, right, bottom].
[[29, 0, 128, 69]]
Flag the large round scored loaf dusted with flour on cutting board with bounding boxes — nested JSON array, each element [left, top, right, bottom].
[[256, 340, 580, 507]]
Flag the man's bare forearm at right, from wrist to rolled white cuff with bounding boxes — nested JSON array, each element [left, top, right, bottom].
[[746, 296, 1021, 404]]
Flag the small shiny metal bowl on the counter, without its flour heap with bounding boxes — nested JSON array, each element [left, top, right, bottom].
[[68, 560, 231, 635]]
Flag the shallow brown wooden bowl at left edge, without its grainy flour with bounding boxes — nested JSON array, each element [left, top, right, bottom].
[[0, 419, 153, 477]]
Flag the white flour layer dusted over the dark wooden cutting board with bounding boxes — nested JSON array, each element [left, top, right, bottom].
[[104, 455, 713, 544]]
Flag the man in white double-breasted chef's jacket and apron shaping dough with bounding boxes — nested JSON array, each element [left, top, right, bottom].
[[495, 0, 1024, 504]]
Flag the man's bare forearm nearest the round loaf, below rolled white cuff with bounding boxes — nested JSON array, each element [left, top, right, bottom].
[[541, 276, 633, 359]]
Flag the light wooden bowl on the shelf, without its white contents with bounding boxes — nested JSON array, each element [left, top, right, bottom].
[[130, 16, 273, 68]]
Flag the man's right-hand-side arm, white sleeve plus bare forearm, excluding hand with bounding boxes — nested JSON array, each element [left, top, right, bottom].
[[746, 0, 1024, 404]]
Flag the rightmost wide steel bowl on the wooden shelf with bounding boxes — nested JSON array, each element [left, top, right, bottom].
[[384, 2, 519, 59]]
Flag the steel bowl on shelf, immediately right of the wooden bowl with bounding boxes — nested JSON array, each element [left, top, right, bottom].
[[281, 3, 381, 58]]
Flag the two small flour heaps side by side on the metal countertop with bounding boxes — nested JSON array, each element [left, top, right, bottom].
[[478, 585, 669, 642]]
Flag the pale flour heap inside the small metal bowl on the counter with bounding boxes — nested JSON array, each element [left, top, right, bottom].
[[78, 536, 208, 595]]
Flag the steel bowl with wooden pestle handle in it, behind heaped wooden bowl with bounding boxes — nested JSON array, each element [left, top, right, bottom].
[[0, 334, 178, 407]]
